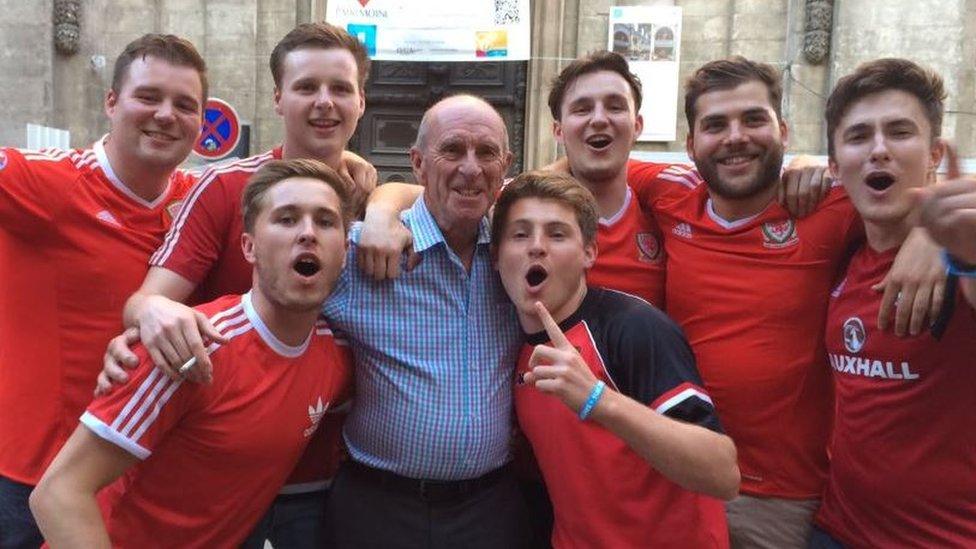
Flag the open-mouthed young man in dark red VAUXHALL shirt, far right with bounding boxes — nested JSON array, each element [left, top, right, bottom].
[[811, 59, 976, 547]]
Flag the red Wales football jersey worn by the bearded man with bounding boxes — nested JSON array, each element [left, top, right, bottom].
[[630, 163, 862, 499]]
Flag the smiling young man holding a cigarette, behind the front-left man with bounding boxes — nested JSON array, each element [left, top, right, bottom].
[[102, 22, 369, 548]]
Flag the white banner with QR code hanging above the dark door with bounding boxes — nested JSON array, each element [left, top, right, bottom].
[[326, 0, 531, 61]]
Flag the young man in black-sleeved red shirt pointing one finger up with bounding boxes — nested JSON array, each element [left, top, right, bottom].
[[492, 172, 739, 548]]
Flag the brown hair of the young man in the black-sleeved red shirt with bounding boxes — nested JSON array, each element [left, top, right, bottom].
[[491, 170, 600, 246]]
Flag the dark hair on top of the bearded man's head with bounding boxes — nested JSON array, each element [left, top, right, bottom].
[[685, 55, 783, 134]]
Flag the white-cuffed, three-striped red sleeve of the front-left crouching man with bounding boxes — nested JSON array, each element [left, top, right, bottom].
[[81, 346, 195, 459]]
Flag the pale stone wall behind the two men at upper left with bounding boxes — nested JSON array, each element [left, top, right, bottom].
[[0, 0, 304, 152]]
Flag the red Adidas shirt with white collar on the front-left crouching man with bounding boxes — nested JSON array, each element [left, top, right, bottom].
[[81, 294, 352, 547]]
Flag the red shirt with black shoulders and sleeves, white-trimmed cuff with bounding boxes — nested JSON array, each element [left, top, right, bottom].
[[514, 288, 729, 549]]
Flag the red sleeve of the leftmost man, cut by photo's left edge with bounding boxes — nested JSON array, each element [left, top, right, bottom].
[[0, 148, 72, 230]]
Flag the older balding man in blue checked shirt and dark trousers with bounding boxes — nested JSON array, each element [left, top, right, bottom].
[[323, 92, 526, 548]]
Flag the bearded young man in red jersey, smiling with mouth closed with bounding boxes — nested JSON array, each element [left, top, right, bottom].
[[630, 57, 942, 547]]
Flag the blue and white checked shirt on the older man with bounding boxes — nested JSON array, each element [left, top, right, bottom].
[[322, 195, 521, 480]]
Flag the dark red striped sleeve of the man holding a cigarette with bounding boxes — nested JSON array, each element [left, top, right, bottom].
[[149, 169, 236, 284]]
